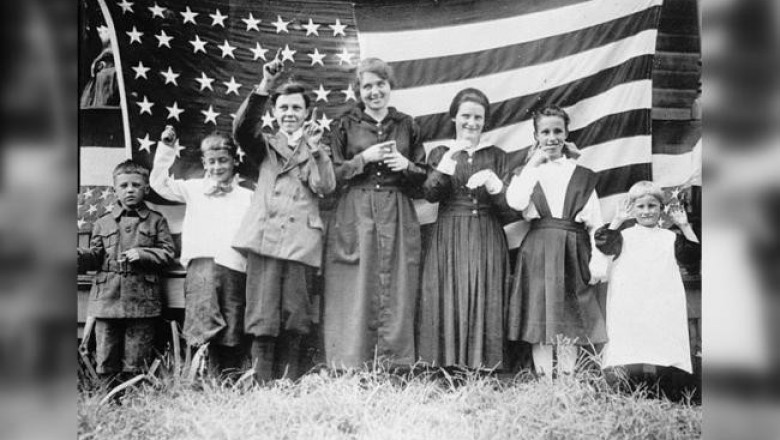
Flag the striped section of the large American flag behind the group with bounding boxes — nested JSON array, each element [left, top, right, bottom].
[[356, 0, 662, 237]]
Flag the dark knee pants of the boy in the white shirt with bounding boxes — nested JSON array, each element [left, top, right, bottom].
[[184, 258, 246, 347]]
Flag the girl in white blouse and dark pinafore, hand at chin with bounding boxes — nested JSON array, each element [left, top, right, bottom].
[[506, 107, 607, 376]]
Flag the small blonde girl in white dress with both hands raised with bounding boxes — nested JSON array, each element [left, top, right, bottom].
[[595, 181, 699, 373]]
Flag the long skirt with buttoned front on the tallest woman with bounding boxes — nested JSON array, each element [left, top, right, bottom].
[[323, 188, 421, 368]]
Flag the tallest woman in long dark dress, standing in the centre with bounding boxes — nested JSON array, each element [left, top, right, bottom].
[[323, 58, 425, 368]]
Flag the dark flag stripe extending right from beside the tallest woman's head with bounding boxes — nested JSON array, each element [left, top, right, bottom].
[[390, 6, 660, 89]]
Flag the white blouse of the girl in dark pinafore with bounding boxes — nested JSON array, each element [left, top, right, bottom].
[[506, 156, 609, 281]]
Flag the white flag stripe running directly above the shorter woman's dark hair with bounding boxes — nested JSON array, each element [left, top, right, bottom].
[[392, 30, 656, 116]]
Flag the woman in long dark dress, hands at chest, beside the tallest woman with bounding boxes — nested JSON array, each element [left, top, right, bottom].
[[419, 89, 509, 368]]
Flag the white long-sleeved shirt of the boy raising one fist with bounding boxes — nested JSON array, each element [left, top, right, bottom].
[[149, 142, 252, 272]]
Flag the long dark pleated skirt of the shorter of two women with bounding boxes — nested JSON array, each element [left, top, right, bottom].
[[418, 213, 510, 368]]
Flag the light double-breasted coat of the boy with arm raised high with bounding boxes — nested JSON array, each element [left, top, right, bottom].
[[233, 93, 336, 267]]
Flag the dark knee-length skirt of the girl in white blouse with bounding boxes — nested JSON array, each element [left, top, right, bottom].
[[508, 219, 607, 345]]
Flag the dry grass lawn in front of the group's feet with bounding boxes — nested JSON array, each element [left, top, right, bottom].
[[78, 360, 702, 440]]
